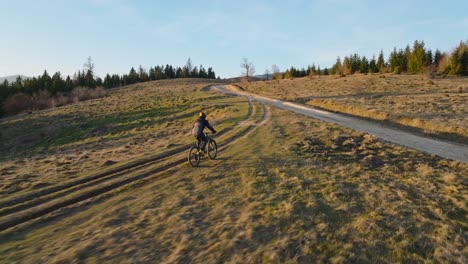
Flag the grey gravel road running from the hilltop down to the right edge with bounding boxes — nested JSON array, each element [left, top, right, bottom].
[[212, 85, 468, 162]]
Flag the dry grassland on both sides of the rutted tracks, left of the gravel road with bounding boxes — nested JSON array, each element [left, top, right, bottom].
[[0, 79, 468, 263]]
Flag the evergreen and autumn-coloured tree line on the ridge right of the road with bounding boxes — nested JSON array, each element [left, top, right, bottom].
[[273, 41, 468, 79]]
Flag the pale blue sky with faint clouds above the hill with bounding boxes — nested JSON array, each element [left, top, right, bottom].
[[0, 0, 468, 78]]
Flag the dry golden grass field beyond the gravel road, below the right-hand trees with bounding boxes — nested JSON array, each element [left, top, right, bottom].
[[240, 74, 468, 140]]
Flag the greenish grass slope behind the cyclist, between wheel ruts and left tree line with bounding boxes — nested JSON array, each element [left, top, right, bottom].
[[0, 80, 248, 197]]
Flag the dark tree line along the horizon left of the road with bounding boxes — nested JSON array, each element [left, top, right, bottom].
[[0, 57, 216, 116]]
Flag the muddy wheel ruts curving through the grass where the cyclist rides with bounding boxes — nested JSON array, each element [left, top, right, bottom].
[[0, 95, 269, 232]]
